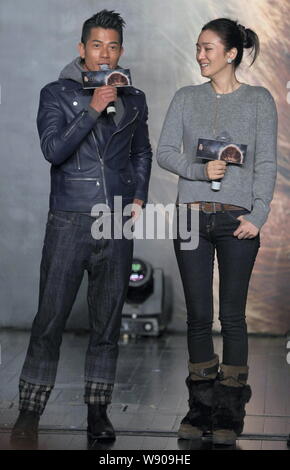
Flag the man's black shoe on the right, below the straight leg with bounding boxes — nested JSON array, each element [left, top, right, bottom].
[[87, 405, 116, 440]]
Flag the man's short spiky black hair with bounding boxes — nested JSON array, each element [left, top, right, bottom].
[[81, 10, 126, 45]]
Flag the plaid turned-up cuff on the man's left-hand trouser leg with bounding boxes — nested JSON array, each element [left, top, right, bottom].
[[19, 380, 53, 415]]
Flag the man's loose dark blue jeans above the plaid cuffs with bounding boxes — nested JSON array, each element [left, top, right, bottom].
[[20, 211, 133, 386]]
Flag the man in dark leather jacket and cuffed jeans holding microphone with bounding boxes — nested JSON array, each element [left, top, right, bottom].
[[11, 10, 152, 443]]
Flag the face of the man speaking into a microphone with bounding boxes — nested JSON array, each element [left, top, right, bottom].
[[79, 28, 123, 71]]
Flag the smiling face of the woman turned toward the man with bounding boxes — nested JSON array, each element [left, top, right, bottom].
[[196, 29, 237, 78]]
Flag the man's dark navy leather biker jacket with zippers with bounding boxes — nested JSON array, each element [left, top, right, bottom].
[[37, 79, 152, 212]]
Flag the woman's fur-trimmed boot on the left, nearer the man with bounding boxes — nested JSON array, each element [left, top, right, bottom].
[[178, 354, 219, 439]]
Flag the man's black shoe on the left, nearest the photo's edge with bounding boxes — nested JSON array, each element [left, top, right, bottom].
[[10, 410, 40, 444]]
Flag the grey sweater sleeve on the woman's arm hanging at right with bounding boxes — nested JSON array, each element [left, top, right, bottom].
[[244, 88, 278, 229]]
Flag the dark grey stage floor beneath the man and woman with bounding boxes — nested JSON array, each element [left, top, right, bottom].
[[0, 330, 290, 451]]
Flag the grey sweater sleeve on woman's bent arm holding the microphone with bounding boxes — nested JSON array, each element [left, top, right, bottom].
[[156, 89, 209, 181]]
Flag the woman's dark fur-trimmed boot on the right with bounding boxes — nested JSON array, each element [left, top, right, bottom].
[[212, 364, 252, 445]]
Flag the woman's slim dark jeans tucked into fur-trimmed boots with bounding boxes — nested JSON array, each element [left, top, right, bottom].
[[174, 208, 260, 366]]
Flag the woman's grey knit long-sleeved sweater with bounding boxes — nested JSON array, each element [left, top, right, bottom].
[[157, 82, 277, 228]]
